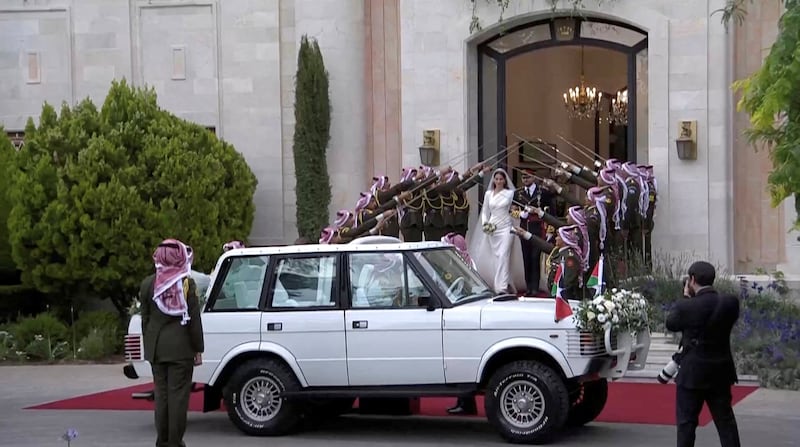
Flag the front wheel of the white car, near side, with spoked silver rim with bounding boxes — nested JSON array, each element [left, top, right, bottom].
[[484, 361, 569, 444]]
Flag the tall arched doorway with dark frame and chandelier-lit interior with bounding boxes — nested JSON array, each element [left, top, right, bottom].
[[477, 17, 648, 184]]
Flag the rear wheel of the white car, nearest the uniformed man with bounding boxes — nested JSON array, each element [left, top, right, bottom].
[[225, 359, 303, 436]]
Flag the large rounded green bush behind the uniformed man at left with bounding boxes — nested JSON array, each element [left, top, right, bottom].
[[9, 81, 256, 311]]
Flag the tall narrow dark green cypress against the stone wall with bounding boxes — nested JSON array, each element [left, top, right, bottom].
[[293, 36, 331, 240]]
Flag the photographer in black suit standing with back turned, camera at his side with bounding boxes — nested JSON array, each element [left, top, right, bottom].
[[666, 261, 740, 447]]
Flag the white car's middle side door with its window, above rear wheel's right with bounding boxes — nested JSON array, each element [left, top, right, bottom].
[[261, 253, 347, 386]]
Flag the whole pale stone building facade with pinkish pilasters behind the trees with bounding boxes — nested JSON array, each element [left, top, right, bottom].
[[0, 0, 800, 273]]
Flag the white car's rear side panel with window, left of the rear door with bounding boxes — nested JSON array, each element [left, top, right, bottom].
[[194, 256, 269, 383]]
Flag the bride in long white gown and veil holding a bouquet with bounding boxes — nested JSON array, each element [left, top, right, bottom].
[[469, 169, 524, 293]]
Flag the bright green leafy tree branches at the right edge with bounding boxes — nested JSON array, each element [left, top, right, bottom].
[[734, 0, 800, 229]]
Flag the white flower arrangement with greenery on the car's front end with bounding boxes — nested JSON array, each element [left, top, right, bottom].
[[573, 289, 649, 335]]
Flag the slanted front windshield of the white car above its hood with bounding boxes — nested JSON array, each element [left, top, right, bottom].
[[414, 248, 494, 304]]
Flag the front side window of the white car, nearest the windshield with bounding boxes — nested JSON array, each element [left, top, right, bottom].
[[350, 253, 431, 309]]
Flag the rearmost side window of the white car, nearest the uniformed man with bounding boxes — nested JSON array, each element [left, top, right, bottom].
[[210, 256, 269, 311]]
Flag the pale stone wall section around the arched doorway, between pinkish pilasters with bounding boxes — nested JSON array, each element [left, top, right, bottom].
[[400, 0, 732, 266]]
